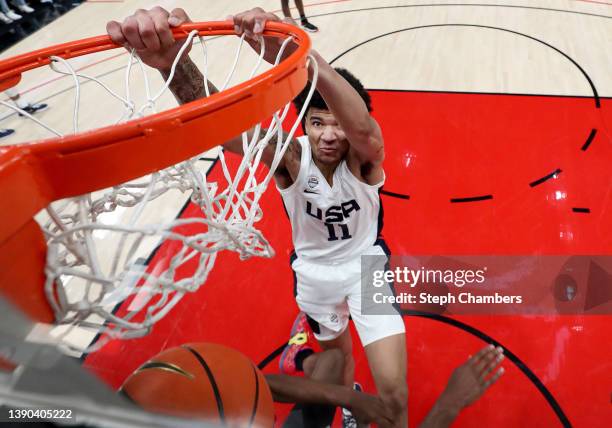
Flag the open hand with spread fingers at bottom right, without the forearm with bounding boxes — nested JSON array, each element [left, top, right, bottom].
[[440, 345, 504, 411]]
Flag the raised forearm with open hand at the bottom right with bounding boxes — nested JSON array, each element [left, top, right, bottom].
[[419, 346, 504, 428]]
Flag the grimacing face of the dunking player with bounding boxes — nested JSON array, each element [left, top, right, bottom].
[[306, 108, 349, 164]]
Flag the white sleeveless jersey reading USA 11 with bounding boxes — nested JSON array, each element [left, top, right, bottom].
[[277, 136, 385, 264]]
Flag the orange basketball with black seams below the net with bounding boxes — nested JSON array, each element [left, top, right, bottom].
[[121, 343, 274, 427]]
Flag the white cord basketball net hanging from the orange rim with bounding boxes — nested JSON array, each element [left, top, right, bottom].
[[2, 31, 317, 352]]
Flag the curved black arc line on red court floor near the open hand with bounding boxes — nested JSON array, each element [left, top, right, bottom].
[[258, 310, 572, 428]]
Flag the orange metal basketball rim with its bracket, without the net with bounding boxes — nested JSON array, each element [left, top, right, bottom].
[[0, 21, 310, 322]]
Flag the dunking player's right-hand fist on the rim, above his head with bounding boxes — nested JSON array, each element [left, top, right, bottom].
[[227, 7, 297, 64]]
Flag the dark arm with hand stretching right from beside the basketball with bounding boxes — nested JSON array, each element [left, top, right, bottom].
[[266, 374, 392, 426]]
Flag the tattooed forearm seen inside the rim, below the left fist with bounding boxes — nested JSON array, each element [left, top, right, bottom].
[[160, 57, 219, 104]]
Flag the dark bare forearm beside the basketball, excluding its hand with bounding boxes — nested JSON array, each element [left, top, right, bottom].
[[266, 374, 352, 408]]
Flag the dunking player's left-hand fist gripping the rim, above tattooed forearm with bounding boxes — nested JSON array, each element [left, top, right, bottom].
[[106, 6, 191, 72]]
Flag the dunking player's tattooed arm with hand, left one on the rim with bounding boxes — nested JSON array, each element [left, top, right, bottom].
[[106, 6, 301, 174]]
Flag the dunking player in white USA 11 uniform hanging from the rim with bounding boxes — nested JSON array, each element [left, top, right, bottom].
[[107, 7, 408, 426]]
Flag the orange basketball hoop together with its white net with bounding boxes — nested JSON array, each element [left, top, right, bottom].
[[0, 22, 316, 351]]
